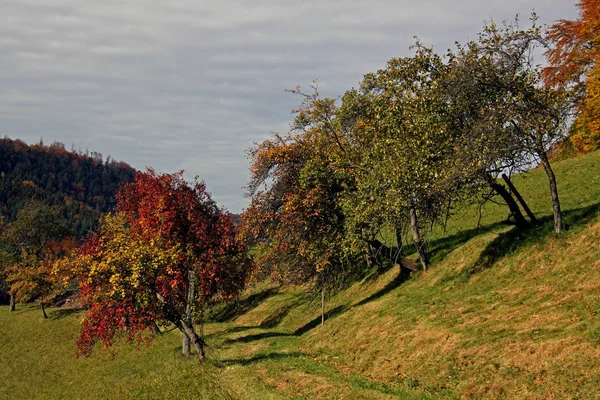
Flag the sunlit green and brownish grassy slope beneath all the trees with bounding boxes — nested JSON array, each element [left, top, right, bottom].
[[0, 153, 600, 399]]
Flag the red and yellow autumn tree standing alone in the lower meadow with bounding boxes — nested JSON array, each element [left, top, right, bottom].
[[75, 170, 250, 360]]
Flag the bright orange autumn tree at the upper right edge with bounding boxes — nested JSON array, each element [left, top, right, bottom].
[[544, 0, 600, 153]]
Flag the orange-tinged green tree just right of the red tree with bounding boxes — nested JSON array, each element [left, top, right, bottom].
[[242, 86, 361, 319]]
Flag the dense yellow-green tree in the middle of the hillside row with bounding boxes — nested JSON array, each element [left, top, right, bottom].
[[339, 43, 458, 269]]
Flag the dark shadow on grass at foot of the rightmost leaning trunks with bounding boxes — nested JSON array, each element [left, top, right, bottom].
[[469, 203, 600, 275]]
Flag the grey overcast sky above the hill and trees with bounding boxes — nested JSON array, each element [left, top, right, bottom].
[[0, 0, 577, 212]]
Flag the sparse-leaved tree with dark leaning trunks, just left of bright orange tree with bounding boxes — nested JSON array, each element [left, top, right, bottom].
[[446, 15, 568, 233]]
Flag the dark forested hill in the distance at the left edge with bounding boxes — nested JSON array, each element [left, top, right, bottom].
[[0, 137, 135, 236]]
